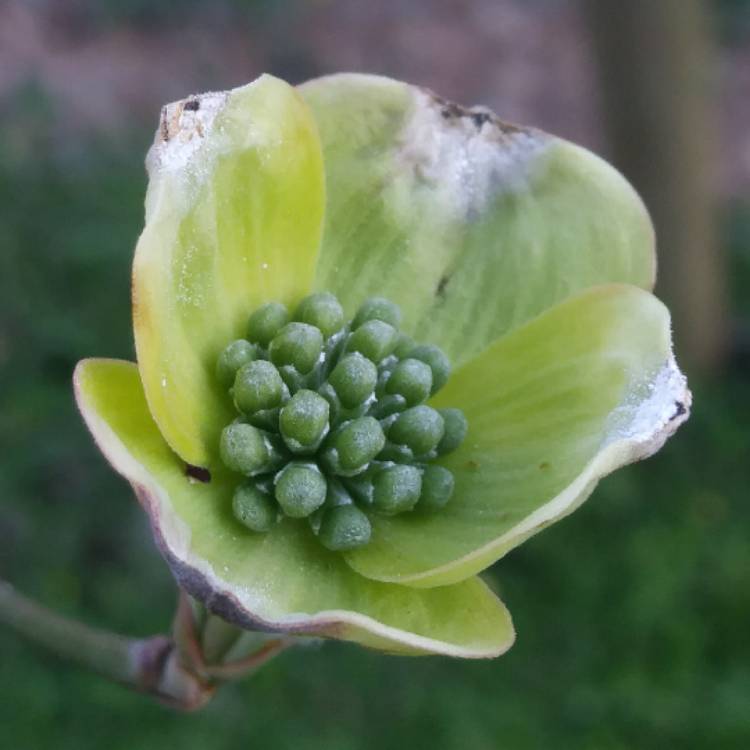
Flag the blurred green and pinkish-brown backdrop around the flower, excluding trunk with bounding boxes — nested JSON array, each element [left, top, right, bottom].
[[0, 0, 750, 750]]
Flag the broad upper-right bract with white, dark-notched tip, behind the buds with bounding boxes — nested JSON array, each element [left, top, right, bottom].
[[300, 74, 655, 365]]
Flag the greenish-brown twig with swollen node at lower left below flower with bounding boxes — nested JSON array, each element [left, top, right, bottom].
[[0, 580, 213, 710]]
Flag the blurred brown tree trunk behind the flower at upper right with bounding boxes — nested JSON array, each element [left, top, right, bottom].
[[584, 0, 728, 374]]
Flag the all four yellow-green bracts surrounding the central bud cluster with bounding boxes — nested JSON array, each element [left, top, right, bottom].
[[75, 74, 690, 657]]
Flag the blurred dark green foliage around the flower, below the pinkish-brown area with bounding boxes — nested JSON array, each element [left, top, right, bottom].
[[0, 0, 750, 750]]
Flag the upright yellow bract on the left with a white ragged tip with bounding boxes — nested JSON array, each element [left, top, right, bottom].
[[133, 76, 325, 466]]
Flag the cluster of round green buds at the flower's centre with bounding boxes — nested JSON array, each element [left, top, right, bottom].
[[216, 292, 467, 550]]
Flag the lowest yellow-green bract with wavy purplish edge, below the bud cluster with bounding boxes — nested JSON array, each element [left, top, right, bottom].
[[75, 360, 514, 657]]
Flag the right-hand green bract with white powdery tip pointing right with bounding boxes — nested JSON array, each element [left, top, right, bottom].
[[347, 285, 690, 587]]
